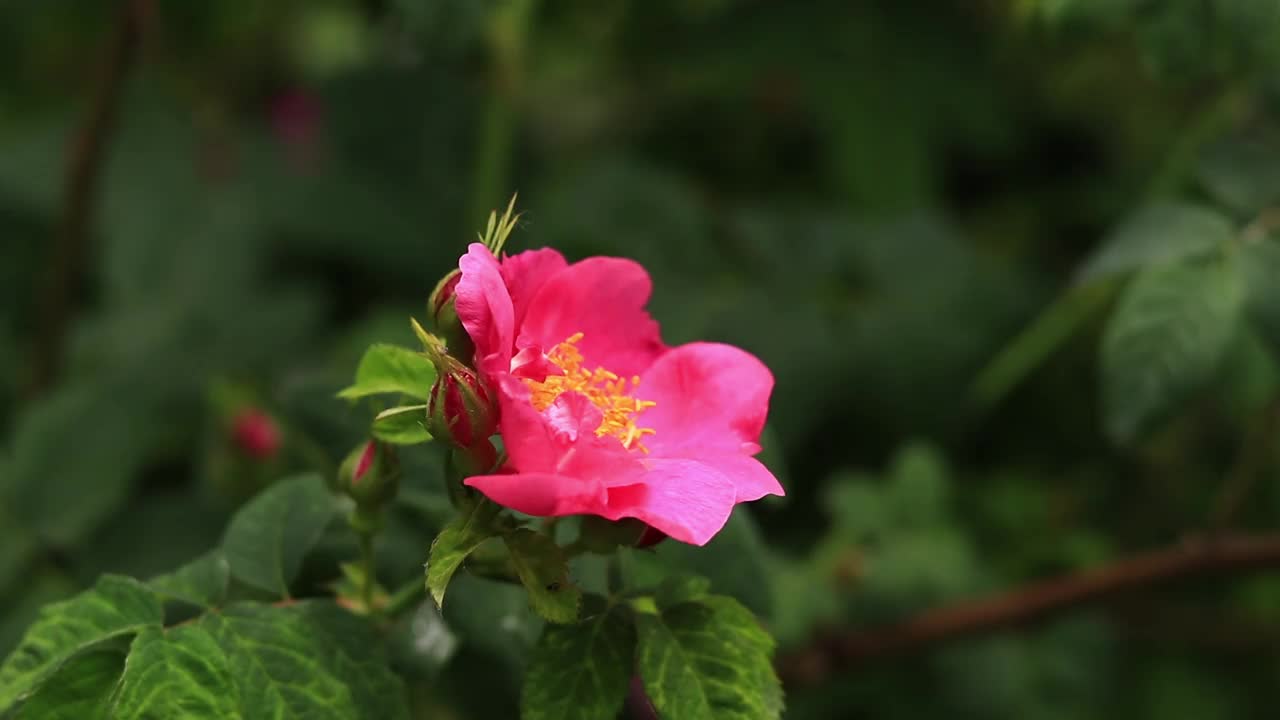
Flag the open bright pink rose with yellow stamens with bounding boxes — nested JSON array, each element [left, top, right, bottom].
[[456, 243, 783, 544]]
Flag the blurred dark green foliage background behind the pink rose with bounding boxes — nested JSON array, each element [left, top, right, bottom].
[[0, 0, 1280, 720]]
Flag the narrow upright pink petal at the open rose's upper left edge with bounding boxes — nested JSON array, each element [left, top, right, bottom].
[[454, 242, 516, 377]]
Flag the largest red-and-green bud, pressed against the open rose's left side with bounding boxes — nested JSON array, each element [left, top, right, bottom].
[[426, 355, 498, 447]]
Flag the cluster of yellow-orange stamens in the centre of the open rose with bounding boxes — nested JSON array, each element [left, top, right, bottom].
[[525, 333, 657, 452]]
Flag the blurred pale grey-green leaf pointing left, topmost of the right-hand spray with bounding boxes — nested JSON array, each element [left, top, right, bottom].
[[1080, 204, 1234, 281]]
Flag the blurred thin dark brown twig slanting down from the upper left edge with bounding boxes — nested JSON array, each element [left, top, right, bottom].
[[27, 0, 152, 398]]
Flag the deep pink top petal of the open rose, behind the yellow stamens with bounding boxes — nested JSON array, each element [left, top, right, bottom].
[[517, 258, 666, 377]]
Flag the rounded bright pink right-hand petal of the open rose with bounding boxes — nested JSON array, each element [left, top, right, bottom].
[[635, 342, 773, 457]]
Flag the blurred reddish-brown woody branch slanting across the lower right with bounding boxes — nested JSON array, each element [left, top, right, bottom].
[[778, 533, 1280, 684]]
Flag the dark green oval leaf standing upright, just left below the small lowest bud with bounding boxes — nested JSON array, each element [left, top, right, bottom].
[[223, 475, 334, 597]]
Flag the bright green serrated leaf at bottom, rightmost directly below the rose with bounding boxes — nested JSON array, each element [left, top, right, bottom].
[[636, 597, 782, 720]]
